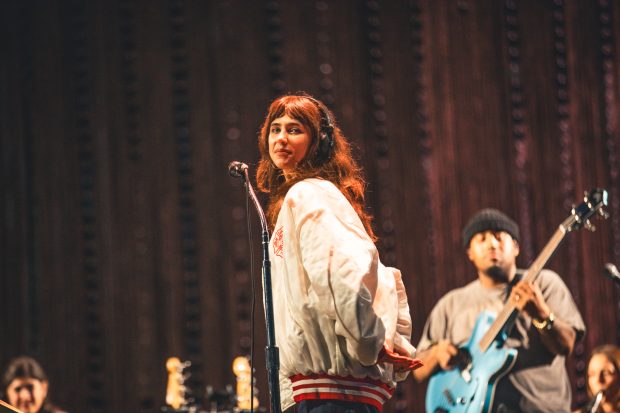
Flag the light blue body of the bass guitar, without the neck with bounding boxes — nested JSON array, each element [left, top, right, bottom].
[[426, 311, 517, 413]]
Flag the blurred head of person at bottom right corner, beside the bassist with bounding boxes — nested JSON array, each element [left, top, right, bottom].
[[587, 344, 620, 412]]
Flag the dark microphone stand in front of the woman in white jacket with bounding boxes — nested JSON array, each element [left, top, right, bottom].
[[242, 168, 281, 413]]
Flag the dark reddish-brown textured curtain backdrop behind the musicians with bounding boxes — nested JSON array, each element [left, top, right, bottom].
[[0, 0, 620, 412]]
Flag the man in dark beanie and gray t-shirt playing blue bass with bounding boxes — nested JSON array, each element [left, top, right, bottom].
[[414, 209, 585, 413]]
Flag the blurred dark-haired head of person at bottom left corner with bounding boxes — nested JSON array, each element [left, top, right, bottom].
[[1, 356, 49, 413]]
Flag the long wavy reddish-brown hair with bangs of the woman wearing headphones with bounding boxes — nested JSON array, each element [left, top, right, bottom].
[[256, 94, 377, 241]]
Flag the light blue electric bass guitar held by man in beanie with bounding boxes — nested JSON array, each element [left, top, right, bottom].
[[426, 189, 607, 413]]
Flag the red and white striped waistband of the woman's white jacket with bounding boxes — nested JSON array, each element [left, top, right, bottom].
[[289, 374, 394, 411]]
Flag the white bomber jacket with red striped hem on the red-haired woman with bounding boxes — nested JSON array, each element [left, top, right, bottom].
[[270, 179, 415, 410]]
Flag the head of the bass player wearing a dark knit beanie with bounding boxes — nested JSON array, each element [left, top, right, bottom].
[[462, 208, 519, 285]]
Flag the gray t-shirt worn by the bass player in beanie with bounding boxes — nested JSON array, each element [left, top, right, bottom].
[[417, 270, 585, 413]]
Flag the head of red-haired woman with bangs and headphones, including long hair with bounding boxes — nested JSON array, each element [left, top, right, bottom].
[[256, 93, 376, 240]]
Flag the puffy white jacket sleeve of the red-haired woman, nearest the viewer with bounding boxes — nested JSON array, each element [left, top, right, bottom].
[[283, 182, 388, 365]]
